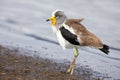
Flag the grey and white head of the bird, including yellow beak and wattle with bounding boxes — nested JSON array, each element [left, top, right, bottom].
[[46, 10, 67, 26]]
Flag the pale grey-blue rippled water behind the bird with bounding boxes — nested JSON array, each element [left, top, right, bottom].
[[0, 0, 120, 79]]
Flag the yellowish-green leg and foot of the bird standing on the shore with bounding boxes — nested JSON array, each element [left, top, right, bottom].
[[67, 48, 79, 75]]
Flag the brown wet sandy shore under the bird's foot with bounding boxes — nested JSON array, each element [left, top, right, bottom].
[[0, 46, 103, 80]]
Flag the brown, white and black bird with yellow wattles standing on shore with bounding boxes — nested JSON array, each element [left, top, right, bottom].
[[46, 10, 109, 75]]
